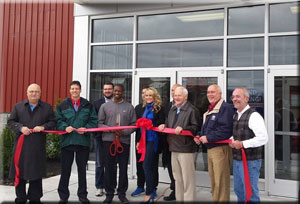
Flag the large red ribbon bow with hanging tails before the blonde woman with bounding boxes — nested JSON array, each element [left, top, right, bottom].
[[136, 117, 152, 162]]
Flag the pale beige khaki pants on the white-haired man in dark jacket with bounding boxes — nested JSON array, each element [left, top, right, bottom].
[[172, 152, 196, 202]]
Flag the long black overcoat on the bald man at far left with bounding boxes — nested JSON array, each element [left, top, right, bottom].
[[7, 100, 56, 180]]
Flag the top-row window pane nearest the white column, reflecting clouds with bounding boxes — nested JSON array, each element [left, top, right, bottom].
[[92, 17, 133, 43]]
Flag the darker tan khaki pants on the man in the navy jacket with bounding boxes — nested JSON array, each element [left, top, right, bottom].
[[207, 145, 232, 202]]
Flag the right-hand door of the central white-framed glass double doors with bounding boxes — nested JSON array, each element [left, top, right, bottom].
[[177, 70, 226, 187]]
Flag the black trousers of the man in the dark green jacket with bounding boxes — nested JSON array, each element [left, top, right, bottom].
[[58, 145, 89, 201]]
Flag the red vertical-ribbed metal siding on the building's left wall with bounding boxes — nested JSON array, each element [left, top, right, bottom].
[[0, 1, 74, 113]]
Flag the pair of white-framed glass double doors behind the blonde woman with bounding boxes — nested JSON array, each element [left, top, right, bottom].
[[131, 70, 226, 187]]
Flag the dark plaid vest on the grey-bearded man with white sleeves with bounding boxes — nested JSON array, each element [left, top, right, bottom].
[[232, 108, 263, 160]]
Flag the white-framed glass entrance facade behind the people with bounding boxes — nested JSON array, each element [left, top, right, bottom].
[[73, 1, 300, 197]]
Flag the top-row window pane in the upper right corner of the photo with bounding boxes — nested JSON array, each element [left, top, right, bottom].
[[270, 2, 299, 32]]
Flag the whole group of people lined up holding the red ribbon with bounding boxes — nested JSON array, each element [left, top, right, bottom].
[[8, 81, 268, 203]]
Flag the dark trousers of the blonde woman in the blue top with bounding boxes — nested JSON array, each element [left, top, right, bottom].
[[143, 141, 159, 195]]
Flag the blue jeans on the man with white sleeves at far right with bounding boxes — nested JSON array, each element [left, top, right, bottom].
[[233, 159, 261, 202]]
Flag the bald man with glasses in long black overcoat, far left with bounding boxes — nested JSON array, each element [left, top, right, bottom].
[[7, 84, 56, 203]]
